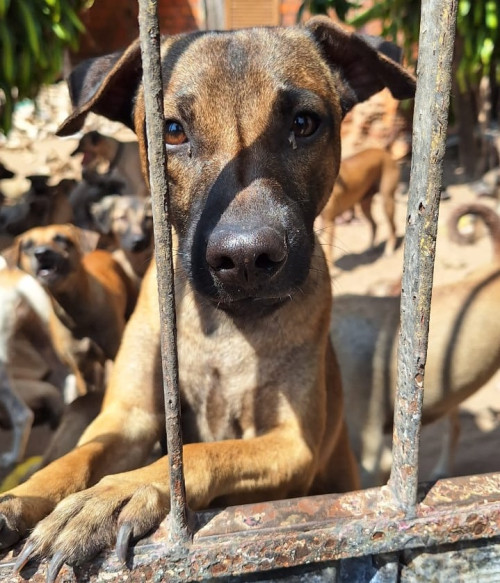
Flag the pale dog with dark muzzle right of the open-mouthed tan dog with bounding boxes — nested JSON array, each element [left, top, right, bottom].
[[91, 195, 154, 289]]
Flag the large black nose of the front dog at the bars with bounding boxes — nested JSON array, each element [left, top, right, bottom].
[[206, 227, 288, 290]]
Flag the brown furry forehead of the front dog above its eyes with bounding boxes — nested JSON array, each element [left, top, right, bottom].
[[163, 28, 340, 116]]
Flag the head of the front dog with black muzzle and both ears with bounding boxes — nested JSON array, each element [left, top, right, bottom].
[[59, 19, 414, 314]]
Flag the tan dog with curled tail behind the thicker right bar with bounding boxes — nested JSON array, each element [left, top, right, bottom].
[[331, 204, 500, 487]]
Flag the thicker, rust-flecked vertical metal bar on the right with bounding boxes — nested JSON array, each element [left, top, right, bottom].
[[389, 0, 457, 516]]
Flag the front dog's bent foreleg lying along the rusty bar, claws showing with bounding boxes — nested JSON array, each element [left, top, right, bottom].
[[16, 424, 320, 576]]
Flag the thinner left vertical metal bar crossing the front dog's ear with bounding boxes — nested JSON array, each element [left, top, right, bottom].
[[139, 0, 191, 543]]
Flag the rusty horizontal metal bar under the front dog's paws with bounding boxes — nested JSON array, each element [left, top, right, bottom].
[[0, 474, 500, 583]]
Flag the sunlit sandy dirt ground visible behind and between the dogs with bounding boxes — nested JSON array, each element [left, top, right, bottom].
[[0, 82, 500, 480]]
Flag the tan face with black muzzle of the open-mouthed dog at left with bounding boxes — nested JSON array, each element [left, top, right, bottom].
[[16, 225, 98, 291]]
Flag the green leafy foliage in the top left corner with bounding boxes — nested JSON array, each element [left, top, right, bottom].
[[0, 0, 92, 133]]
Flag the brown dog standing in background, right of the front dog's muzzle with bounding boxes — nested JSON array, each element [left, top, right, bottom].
[[318, 148, 400, 267]]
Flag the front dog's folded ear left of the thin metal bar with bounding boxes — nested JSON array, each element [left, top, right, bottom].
[[56, 40, 142, 136]]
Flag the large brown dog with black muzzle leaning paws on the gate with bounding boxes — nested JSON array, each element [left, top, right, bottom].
[[0, 18, 415, 580]]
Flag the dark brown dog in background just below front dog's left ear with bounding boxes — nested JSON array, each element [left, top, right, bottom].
[[71, 131, 149, 196]]
